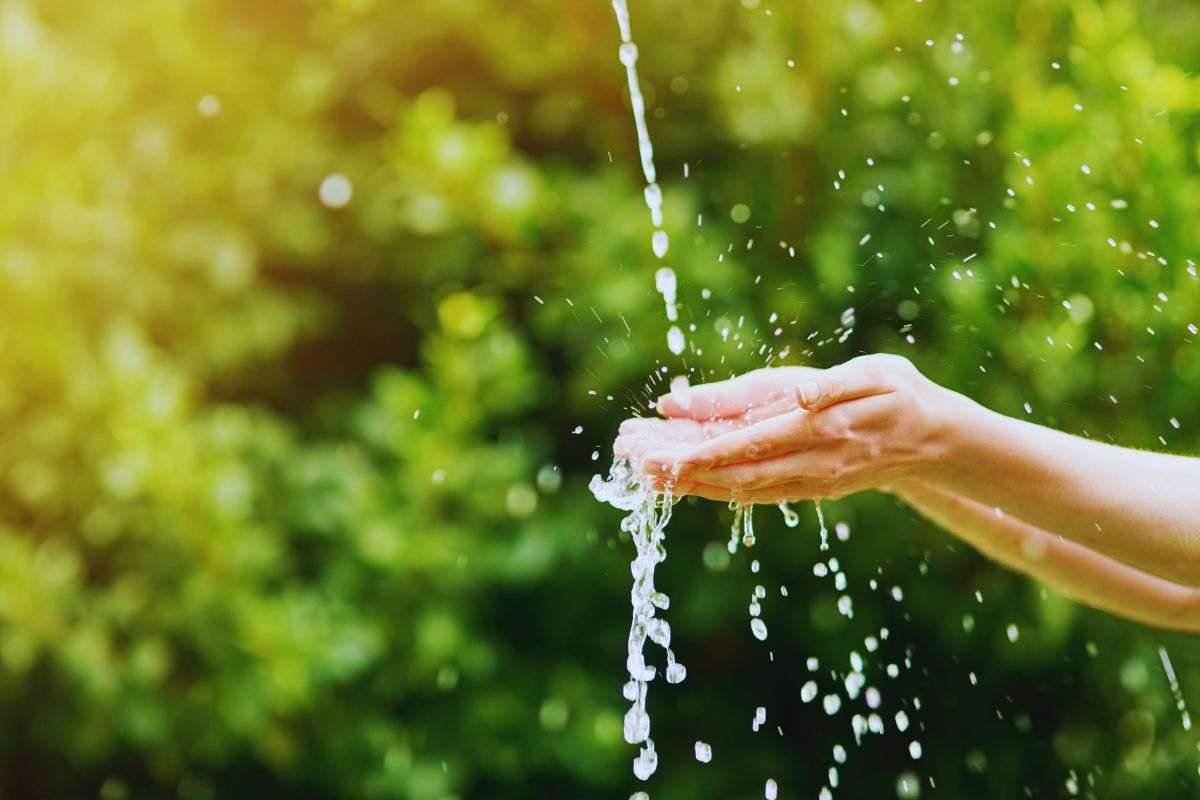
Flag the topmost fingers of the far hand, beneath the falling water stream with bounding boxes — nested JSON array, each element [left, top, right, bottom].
[[658, 367, 821, 420]]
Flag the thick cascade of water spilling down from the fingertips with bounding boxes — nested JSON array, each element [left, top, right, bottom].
[[589, 459, 688, 781]]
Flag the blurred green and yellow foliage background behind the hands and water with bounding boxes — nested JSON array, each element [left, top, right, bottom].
[[7, 0, 1200, 800]]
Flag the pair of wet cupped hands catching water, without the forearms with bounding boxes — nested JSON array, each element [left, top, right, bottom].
[[613, 355, 953, 504]]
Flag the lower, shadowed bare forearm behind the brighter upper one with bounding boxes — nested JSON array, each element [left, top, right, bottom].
[[893, 481, 1200, 631]]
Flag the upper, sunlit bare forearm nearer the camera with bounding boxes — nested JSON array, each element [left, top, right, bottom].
[[918, 396, 1200, 585]]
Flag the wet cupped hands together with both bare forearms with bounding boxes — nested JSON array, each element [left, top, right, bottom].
[[614, 355, 1200, 631]]
